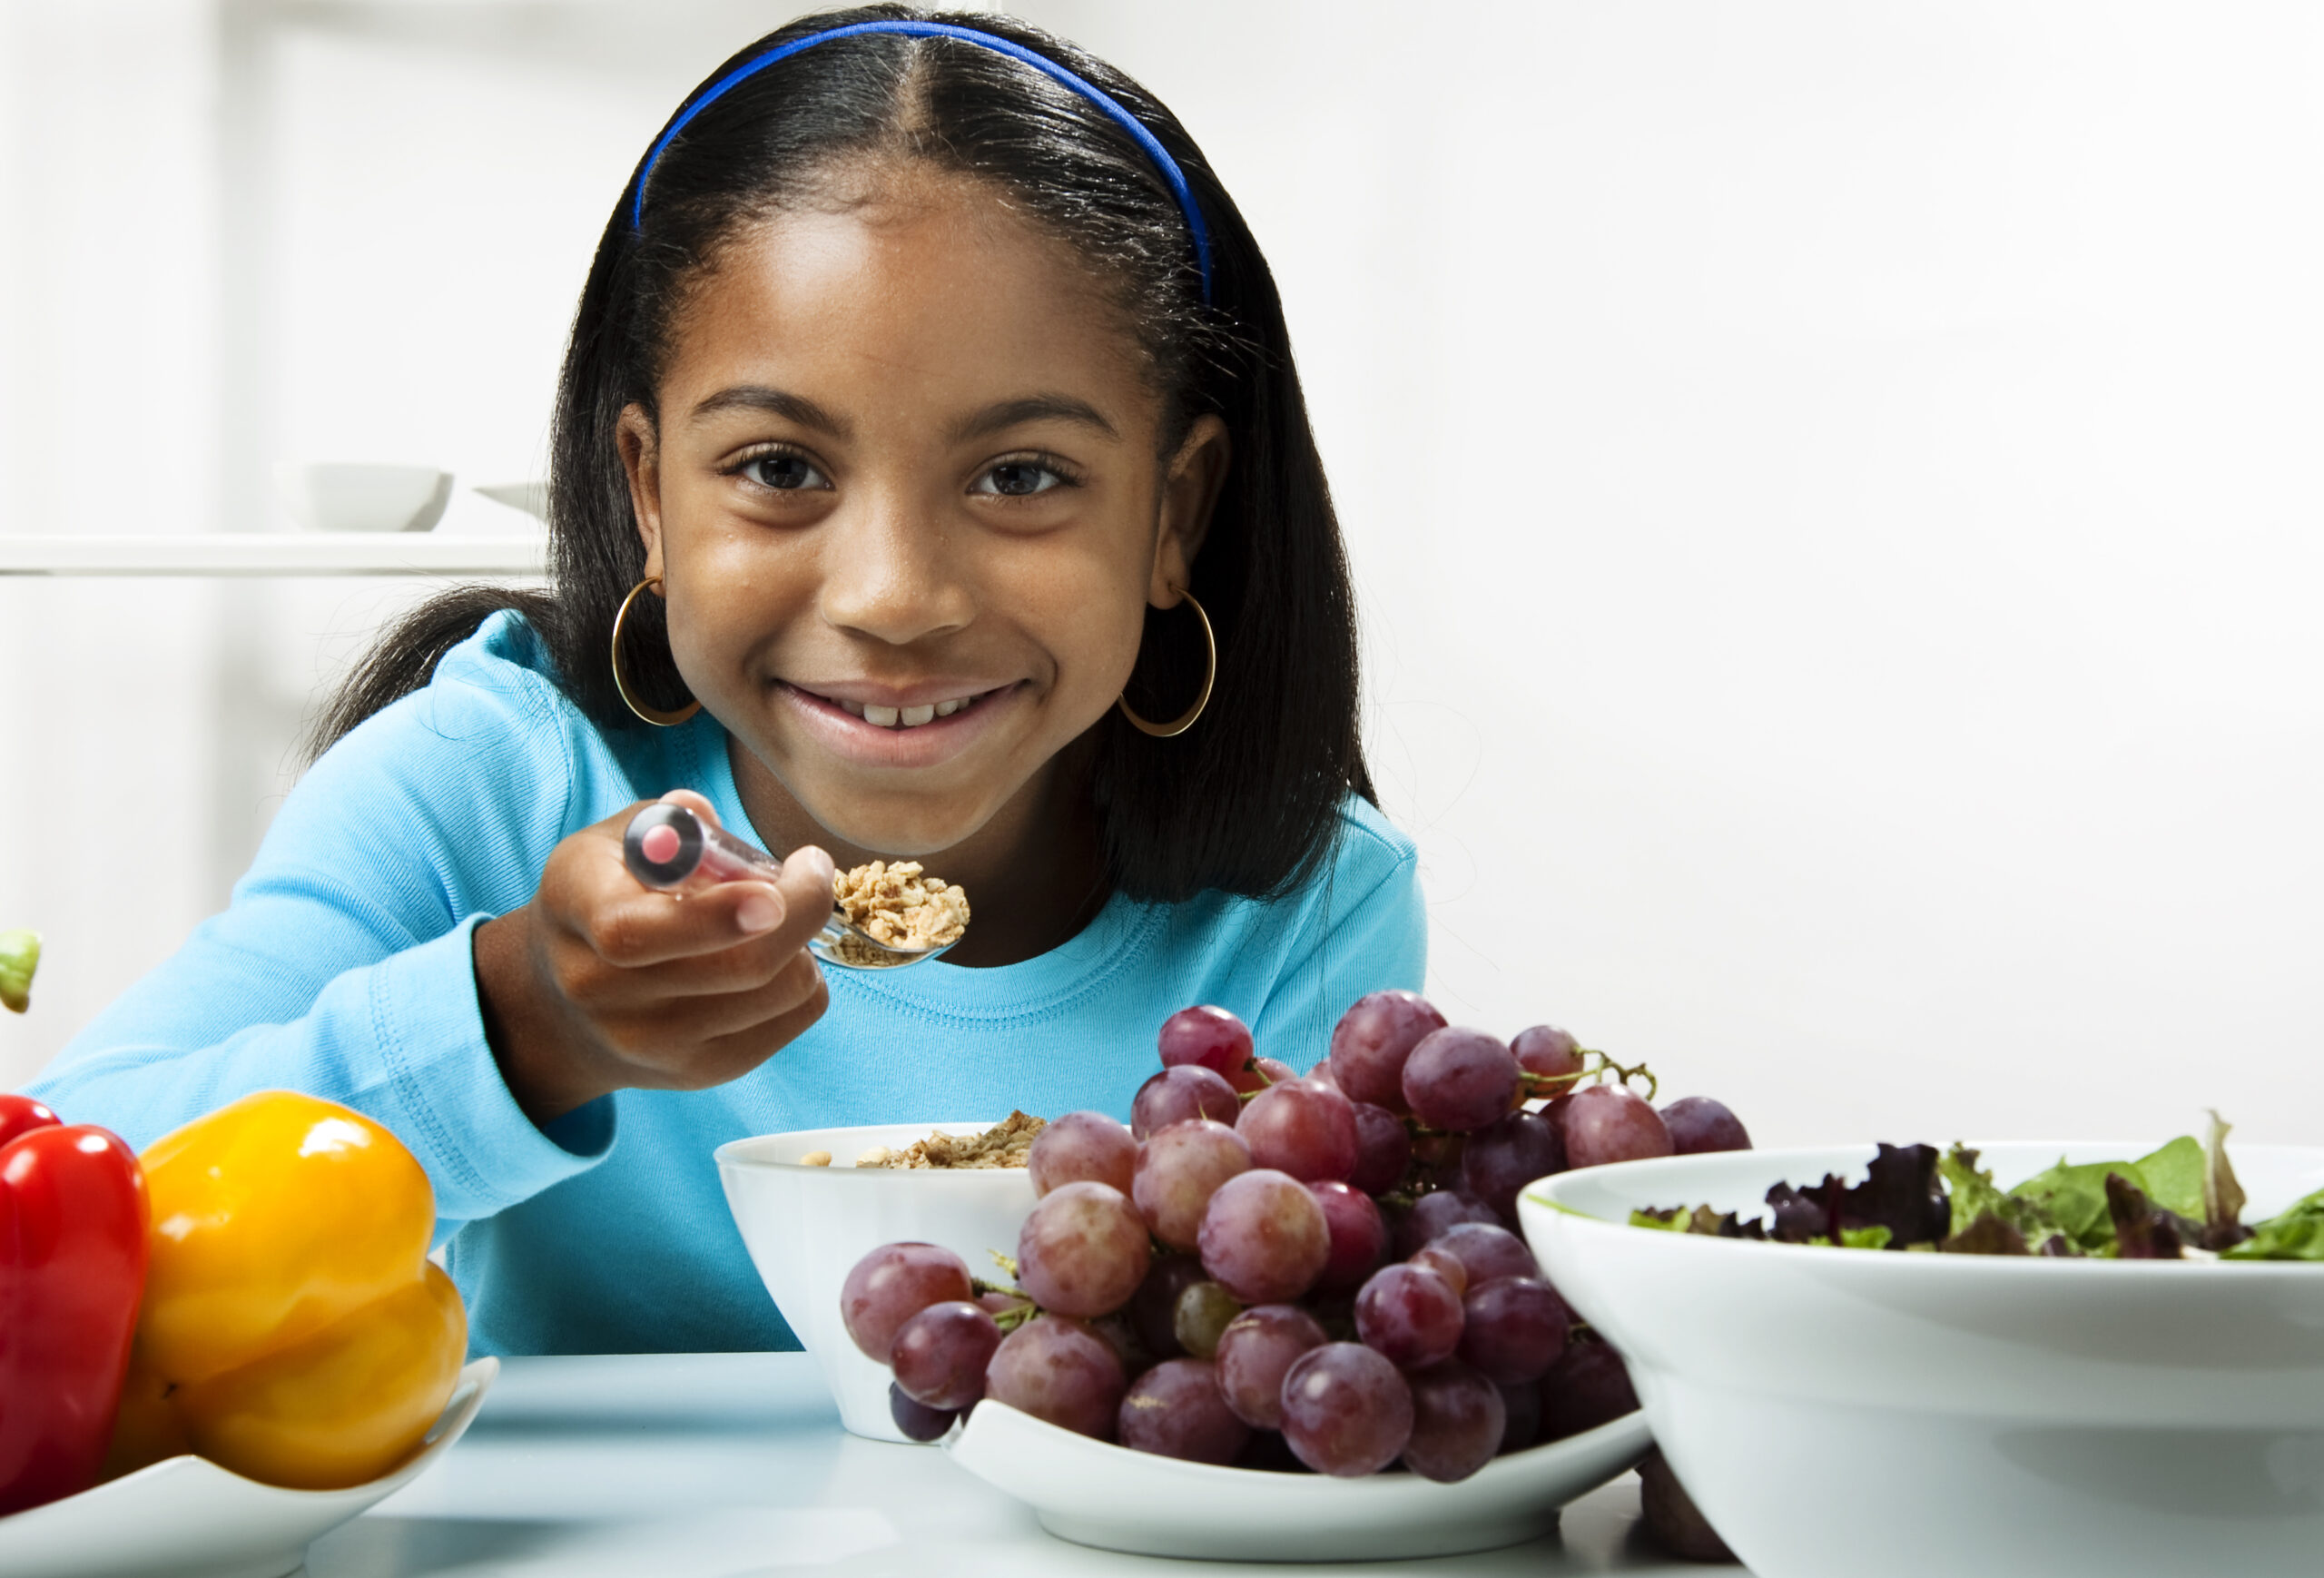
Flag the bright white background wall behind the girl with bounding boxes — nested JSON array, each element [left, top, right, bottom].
[[0, 0, 2324, 1161]]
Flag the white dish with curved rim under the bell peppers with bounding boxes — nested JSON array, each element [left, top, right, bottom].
[[0, 1359, 499, 1578]]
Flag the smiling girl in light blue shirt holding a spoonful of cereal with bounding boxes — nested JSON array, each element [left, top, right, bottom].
[[37, 7, 1423, 1353]]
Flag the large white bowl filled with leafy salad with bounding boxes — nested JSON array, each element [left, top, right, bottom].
[[1518, 1141, 2324, 1578]]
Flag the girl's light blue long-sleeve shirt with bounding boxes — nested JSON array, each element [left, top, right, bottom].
[[33, 614, 1424, 1353]]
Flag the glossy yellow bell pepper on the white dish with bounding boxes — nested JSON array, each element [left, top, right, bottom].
[[109, 1090, 468, 1490]]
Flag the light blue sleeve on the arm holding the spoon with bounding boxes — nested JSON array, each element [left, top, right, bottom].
[[33, 656, 614, 1237]]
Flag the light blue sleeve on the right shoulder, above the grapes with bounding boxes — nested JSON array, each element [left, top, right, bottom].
[[1253, 804, 1429, 1074]]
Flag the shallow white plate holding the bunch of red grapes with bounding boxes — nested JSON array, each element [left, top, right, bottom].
[[946, 1401, 1652, 1562]]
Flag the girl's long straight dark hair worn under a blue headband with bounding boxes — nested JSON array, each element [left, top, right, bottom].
[[311, 5, 1374, 902]]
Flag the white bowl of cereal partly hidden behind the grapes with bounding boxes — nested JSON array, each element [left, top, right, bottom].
[[715, 1120, 1034, 1441]]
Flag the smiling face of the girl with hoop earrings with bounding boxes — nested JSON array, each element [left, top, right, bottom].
[[621, 172, 1227, 855]]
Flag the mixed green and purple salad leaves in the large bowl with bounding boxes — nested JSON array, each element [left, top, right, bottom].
[[1630, 1113, 2324, 1262]]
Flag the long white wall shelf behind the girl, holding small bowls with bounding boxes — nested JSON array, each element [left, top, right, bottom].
[[0, 532, 548, 578]]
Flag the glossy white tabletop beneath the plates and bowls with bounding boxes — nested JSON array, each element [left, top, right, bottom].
[[307, 1353, 1710, 1578]]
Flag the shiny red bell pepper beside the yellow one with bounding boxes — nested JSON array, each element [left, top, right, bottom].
[[0, 1095, 146, 1515]]
